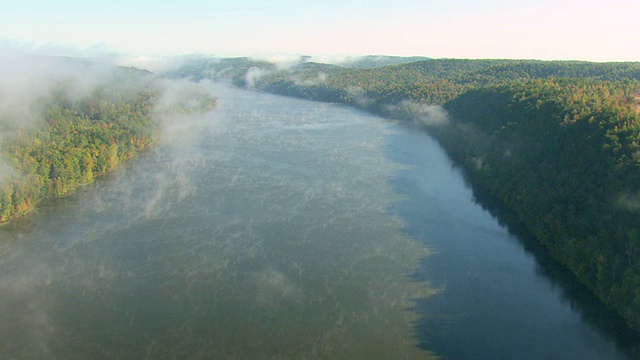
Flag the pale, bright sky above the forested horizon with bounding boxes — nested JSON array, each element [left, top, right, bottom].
[[0, 0, 640, 61]]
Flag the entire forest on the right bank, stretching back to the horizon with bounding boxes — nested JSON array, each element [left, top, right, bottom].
[[172, 58, 640, 331]]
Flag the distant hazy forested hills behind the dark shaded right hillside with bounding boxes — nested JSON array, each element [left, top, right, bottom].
[[246, 59, 640, 107]]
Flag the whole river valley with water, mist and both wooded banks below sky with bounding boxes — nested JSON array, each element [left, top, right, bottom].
[[0, 57, 640, 360]]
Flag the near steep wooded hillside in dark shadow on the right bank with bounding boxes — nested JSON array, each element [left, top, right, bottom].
[[438, 79, 640, 329]]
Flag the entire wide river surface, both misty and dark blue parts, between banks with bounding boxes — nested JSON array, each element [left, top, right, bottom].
[[0, 84, 635, 359]]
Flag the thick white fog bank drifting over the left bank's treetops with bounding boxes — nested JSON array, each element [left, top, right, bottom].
[[0, 44, 215, 185]]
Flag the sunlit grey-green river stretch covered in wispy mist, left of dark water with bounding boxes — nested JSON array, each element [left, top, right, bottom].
[[0, 88, 434, 359]]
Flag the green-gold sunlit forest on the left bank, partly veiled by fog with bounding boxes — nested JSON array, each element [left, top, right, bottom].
[[0, 63, 215, 222]]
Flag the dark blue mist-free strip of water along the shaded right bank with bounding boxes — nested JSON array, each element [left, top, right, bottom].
[[388, 130, 640, 360]]
